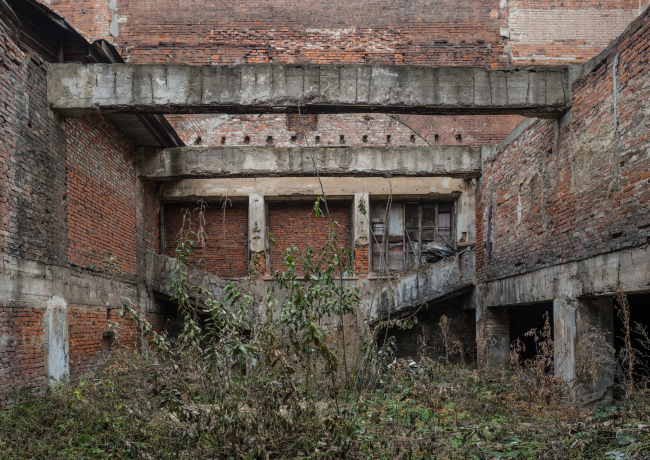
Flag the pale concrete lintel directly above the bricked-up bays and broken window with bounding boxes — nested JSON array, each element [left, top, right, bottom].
[[161, 176, 465, 200]]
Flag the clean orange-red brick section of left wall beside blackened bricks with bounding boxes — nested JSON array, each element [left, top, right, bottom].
[[65, 115, 138, 275]]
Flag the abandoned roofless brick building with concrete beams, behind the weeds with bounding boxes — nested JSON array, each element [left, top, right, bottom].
[[0, 0, 650, 402]]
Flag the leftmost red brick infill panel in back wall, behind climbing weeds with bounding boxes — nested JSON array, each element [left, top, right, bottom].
[[165, 201, 248, 278]]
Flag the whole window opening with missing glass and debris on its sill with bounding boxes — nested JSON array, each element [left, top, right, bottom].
[[371, 201, 455, 273]]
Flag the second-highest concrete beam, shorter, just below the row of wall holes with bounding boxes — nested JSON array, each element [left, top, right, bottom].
[[138, 145, 481, 180]]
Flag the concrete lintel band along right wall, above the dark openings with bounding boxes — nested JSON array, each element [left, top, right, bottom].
[[479, 246, 650, 308]]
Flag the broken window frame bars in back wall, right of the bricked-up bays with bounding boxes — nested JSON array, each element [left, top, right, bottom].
[[369, 200, 456, 274]]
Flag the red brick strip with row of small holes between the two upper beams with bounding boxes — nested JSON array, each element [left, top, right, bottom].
[[167, 113, 523, 151]]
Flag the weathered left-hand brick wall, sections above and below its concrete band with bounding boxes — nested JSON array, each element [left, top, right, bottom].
[[0, 21, 159, 404]]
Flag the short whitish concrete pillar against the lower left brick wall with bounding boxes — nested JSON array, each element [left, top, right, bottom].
[[43, 297, 70, 385]]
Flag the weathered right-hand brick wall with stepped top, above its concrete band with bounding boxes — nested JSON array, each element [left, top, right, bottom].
[[477, 12, 650, 281]]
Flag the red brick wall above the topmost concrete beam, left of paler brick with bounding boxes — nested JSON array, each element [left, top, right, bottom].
[[114, 0, 508, 66]]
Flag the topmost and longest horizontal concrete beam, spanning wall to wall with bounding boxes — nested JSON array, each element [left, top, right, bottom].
[[48, 64, 570, 117]]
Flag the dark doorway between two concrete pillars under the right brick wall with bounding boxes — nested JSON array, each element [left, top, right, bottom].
[[508, 302, 553, 361]]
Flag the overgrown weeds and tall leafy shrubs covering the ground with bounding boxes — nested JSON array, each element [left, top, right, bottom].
[[0, 203, 650, 459]]
